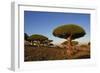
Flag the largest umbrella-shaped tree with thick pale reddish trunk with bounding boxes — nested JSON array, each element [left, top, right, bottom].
[[53, 24, 85, 55]]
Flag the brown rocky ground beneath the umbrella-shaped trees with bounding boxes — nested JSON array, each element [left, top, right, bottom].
[[24, 45, 90, 61]]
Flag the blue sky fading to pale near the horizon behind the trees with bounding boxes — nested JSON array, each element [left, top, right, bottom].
[[24, 11, 90, 44]]
